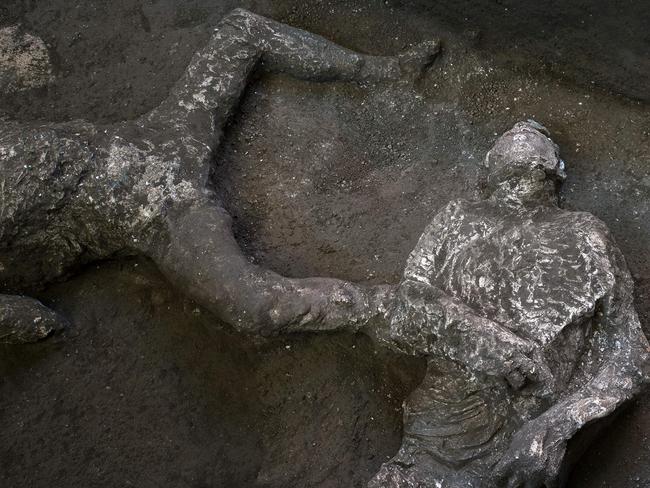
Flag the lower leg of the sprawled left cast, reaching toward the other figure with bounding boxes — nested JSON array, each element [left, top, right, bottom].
[[147, 201, 390, 335]]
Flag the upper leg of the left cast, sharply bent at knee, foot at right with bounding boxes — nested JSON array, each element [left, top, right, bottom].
[[142, 9, 439, 146]]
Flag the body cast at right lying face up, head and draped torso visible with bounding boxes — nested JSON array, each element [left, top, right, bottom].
[[370, 121, 650, 488]]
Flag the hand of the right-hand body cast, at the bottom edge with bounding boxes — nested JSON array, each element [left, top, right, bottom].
[[493, 420, 566, 488]]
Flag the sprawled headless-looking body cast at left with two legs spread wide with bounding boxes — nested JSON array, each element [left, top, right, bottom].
[[0, 10, 439, 342]]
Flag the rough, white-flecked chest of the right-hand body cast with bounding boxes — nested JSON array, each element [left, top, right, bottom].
[[404, 200, 615, 345]]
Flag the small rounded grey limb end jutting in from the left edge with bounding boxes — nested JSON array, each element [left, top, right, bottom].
[[0, 295, 64, 344]]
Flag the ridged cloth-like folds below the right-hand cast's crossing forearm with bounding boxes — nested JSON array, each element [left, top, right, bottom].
[[368, 358, 514, 488]]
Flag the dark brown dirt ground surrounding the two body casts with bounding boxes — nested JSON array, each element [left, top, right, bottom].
[[0, 0, 650, 488]]
